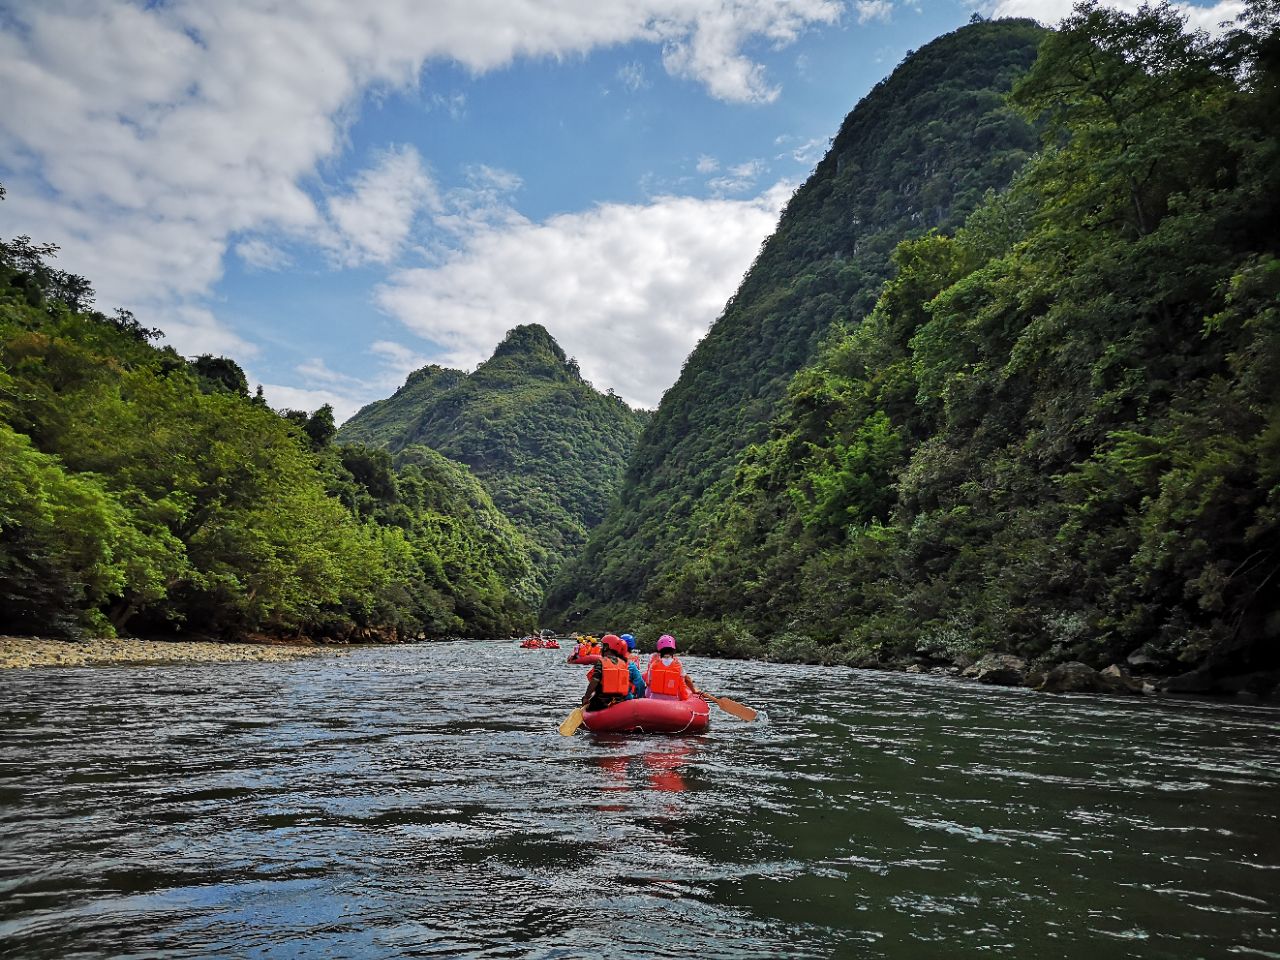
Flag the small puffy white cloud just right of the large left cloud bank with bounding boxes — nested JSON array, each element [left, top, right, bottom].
[[328, 146, 440, 266]]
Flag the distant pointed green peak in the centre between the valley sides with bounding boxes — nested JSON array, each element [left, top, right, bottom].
[[338, 324, 648, 582]]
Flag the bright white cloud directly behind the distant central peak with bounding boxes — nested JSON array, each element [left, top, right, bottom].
[[378, 184, 791, 407]]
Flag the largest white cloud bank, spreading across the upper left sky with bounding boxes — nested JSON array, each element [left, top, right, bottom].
[[0, 0, 841, 363]]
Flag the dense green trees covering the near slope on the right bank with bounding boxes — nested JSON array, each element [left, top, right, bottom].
[[568, 0, 1280, 673]]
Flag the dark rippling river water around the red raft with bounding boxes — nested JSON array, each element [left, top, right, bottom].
[[0, 643, 1280, 960]]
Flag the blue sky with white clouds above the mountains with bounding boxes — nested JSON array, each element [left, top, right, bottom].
[[0, 0, 1242, 421]]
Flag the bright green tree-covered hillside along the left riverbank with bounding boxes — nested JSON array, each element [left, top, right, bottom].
[[0, 229, 536, 639]]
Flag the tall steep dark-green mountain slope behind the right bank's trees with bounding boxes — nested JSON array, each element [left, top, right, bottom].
[[548, 20, 1044, 623]]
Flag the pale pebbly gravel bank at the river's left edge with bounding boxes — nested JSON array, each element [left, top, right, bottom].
[[0, 636, 344, 669]]
